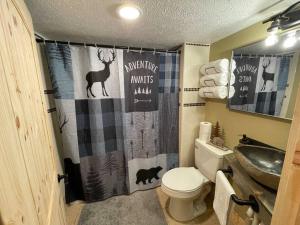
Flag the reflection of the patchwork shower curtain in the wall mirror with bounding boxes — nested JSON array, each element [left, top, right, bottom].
[[229, 54, 293, 116]]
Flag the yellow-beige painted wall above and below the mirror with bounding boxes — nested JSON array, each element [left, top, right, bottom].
[[206, 23, 291, 149]]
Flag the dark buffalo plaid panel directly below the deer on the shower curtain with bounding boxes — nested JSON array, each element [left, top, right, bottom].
[[75, 99, 124, 157]]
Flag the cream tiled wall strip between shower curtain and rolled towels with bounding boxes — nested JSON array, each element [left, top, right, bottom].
[[179, 43, 209, 166]]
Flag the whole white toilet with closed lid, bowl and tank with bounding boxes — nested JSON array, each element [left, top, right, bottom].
[[161, 139, 233, 221]]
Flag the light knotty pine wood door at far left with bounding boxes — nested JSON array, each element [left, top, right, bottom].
[[0, 0, 66, 225]]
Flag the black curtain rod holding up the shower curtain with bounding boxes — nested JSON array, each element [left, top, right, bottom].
[[35, 38, 181, 54]]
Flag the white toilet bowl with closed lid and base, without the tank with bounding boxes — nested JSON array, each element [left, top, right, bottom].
[[161, 167, 211, 221]]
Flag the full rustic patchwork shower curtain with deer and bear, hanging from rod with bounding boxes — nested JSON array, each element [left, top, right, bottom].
[[43, 43, 179, 202]]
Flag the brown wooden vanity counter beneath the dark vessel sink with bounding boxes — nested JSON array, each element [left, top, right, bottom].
[[224, 154, 276, 225]]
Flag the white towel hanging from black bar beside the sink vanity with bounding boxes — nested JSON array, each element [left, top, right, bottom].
[[213, 170, 235, 225]]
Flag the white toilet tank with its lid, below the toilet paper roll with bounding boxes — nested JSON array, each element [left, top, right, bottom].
[[195, 139, 233, 183]]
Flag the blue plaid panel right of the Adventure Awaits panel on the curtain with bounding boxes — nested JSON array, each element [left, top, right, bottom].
[[159, 53, 180, 93]]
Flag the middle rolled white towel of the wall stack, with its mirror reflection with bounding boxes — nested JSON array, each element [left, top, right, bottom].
[[200, 73, 235, 87]]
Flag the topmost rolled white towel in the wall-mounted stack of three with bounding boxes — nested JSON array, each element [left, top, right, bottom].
[[200, 59, 229, 75]]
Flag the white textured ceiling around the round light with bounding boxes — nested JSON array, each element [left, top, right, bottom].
[[25, 0, 296, 48]]
